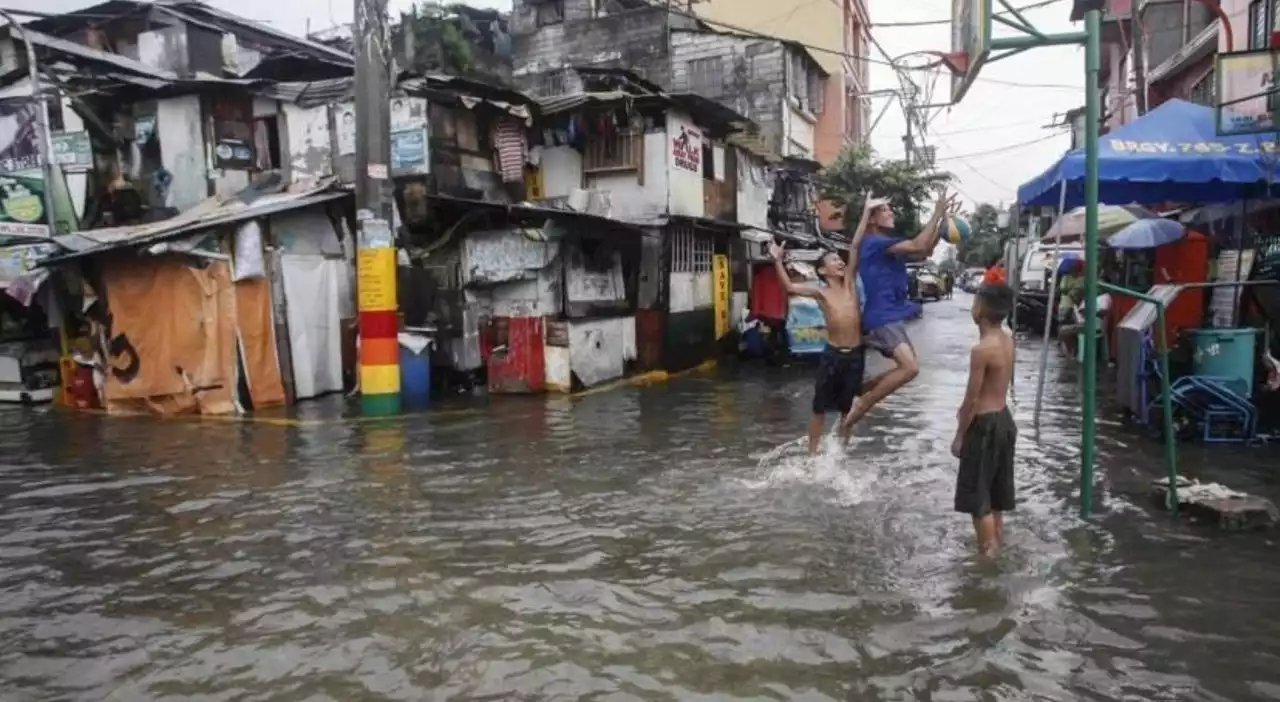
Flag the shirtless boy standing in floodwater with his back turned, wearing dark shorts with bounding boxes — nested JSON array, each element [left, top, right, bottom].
[[951, 283, 1018, 556]]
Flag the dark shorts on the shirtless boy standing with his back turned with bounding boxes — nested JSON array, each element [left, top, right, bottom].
[[956, 407, 1018, 518]]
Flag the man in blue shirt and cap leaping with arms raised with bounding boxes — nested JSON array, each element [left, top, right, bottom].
[[841, 190, 957, 437]]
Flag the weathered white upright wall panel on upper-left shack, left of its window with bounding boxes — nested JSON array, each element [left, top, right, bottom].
[[156, 95, 207, 210]]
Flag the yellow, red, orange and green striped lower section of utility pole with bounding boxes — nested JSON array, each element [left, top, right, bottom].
[[356, 218, 401, 415]]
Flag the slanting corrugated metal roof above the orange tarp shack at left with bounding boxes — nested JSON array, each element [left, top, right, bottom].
[[40, 182, 351, 265]]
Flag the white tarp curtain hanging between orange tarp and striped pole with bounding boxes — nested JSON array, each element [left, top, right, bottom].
[[280, 254, 346, 400]]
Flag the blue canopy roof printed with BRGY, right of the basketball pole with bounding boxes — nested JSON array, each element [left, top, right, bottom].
[[1018, 100, 1280, 208]]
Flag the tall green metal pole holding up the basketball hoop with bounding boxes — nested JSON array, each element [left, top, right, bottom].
[[1080, 10, 1102, 518]]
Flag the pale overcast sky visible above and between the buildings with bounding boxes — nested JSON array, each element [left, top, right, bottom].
[[15, 0, 1084, 204]]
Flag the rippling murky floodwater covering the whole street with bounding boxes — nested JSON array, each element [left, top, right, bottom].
[[0, 296, 1280, 702]]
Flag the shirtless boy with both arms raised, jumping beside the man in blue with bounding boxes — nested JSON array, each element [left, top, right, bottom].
[[769, 196, 884, 456]]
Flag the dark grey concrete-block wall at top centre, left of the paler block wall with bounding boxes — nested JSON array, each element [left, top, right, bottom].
[[509, 0, 671, 91]]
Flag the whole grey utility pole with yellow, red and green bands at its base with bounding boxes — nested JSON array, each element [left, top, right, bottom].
[[353, 0, 401, 415]]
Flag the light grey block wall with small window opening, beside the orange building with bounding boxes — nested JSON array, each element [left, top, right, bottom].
[[671, 32, 787, 154]]
